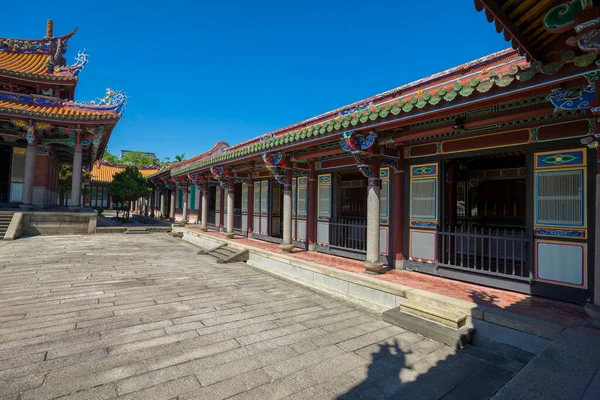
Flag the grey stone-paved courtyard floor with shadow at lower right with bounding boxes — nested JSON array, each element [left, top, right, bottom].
[[0, 234, 536, 400]]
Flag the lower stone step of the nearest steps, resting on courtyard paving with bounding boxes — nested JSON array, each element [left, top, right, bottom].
[[383, 307, 475, 349]]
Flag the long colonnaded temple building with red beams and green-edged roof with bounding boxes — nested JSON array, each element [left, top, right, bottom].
[[149, 0, 600, 310]]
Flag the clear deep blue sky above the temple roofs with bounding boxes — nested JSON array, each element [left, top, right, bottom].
[[0, 0, 508, 158]]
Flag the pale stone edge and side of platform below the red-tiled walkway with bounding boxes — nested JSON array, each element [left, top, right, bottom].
[[177, 228, 580, 354]]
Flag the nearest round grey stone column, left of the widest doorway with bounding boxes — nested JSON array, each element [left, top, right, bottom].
[[364, 157, 383, 273]]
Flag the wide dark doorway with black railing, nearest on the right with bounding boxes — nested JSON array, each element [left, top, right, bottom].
[[438, 152, 531, 282]]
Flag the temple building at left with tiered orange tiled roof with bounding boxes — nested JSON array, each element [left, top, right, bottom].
[[0, 21, 127, 210]]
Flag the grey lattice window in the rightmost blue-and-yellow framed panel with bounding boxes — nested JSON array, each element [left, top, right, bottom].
[[536, 169, 584, 226]]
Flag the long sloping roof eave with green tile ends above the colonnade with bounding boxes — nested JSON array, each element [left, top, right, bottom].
[[170, 52, 598, 177]]
